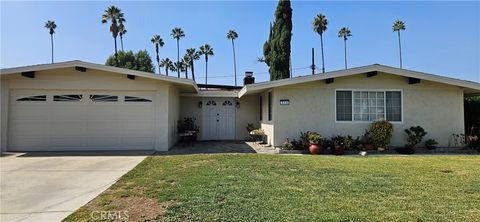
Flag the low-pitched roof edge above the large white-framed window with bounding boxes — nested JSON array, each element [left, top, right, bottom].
[[238, 64, 480, 97]]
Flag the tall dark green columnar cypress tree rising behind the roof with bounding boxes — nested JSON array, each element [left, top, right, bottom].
[[263, 0, 292, 80]]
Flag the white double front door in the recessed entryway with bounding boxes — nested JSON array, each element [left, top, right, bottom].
[[201, 98, 235, 140]]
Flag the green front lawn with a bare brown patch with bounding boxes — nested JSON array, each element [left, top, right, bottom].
[[65, 154, 480, 221]]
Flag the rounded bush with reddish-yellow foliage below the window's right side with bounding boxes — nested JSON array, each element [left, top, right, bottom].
[[370, 120, 393, 149]]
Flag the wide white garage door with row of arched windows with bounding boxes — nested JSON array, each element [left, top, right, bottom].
[[8, 90, 155, 151]]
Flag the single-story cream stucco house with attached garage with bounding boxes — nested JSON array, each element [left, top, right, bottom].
[[0, 61, 480, 151]]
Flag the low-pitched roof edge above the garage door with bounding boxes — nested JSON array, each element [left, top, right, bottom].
[[0, 60, 199, 93]]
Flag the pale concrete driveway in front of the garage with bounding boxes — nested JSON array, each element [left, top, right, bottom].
[[0, 152, 152, 222]]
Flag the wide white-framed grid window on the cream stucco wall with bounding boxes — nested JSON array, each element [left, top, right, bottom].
[[336, 90, 402, 121]]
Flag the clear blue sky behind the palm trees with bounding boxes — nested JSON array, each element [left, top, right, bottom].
[[0, 1, 480, 84]]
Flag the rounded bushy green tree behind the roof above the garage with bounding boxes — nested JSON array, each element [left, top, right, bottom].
[[105, 50, 155, 73]]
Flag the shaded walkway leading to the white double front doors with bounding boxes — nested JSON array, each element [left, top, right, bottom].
[[166, 141, 276, 155]]
